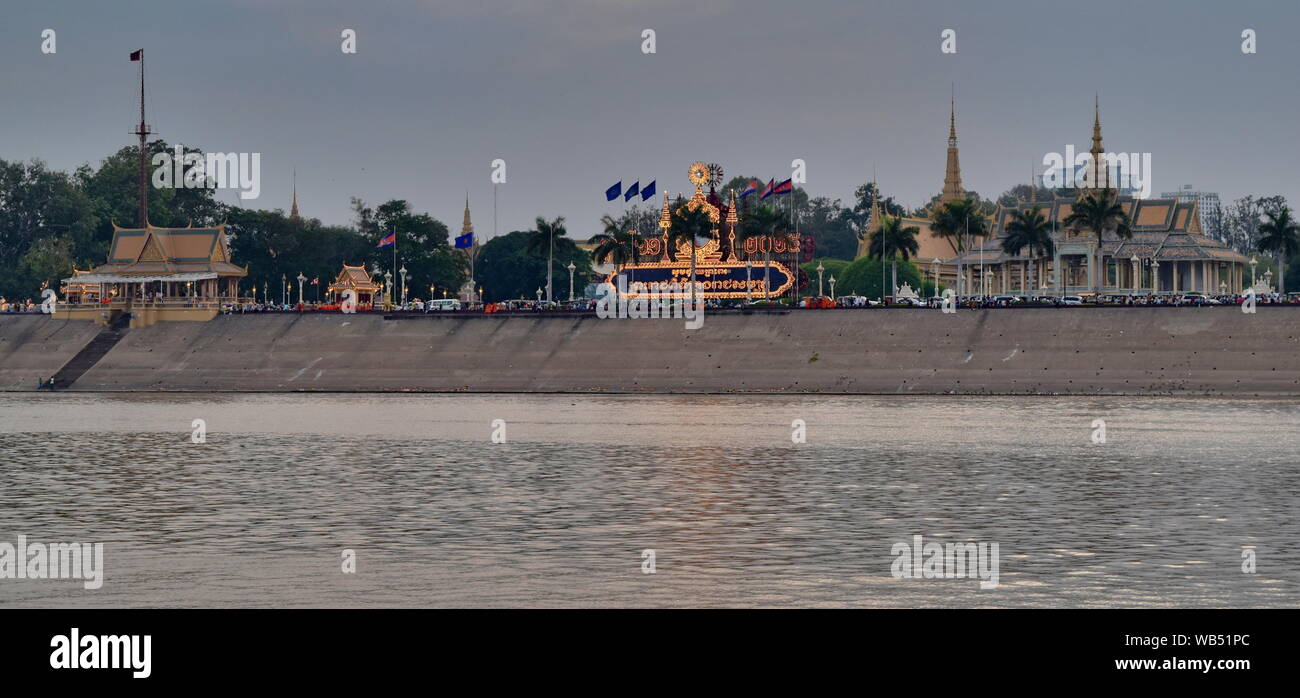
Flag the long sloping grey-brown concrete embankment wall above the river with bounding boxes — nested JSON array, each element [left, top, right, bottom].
[[0, 307, 1300, 395]]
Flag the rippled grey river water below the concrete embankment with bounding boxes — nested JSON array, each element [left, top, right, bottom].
[[0, 394, 1300, 607]]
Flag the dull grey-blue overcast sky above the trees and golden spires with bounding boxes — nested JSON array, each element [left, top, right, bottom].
[[0, 0, 1300, 237]]
